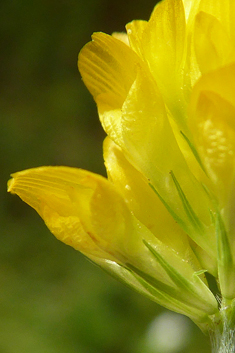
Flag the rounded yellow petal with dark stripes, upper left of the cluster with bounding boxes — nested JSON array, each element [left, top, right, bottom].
[[78, 33, 138, 111]]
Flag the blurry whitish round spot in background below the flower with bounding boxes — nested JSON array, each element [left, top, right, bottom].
[[146, 312, 192, 353]]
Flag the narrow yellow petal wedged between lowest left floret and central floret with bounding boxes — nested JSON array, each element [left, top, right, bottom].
[[104, 138, 203, 270]]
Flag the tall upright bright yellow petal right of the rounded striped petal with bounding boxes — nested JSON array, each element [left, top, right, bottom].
[[138, 0, 189, 121]]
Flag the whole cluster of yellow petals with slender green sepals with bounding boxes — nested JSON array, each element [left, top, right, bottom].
[[9, 0, 235, 328]]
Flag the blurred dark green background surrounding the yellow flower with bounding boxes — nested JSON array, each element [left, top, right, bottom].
[[0, 0, 210, 353]]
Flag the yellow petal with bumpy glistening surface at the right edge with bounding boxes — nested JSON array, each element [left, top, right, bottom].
[[192, 91, 235, 187]]
